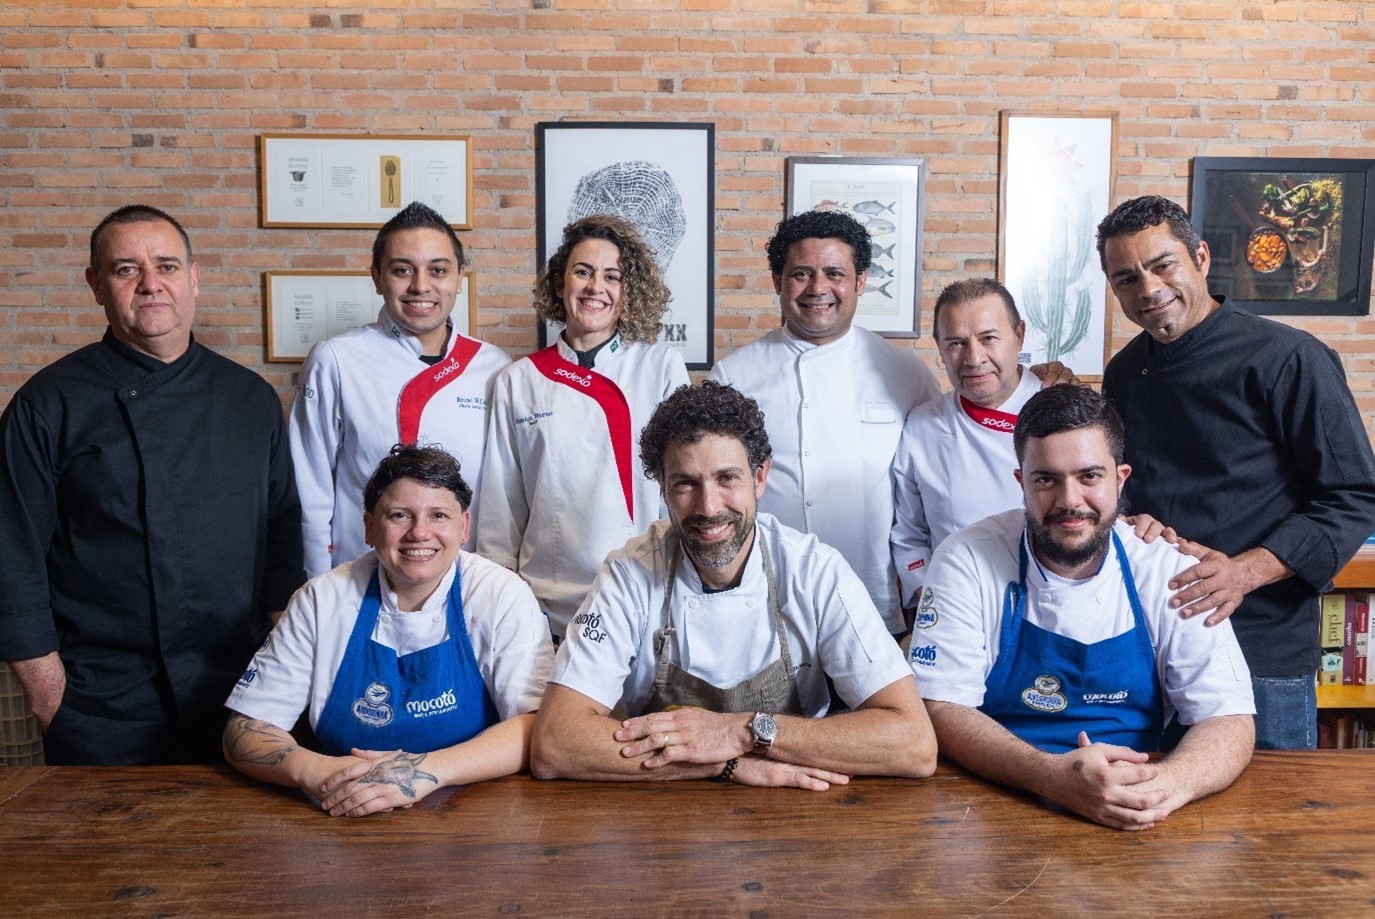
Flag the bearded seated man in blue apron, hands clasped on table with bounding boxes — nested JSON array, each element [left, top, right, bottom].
[[910, 385, 1255, 830]]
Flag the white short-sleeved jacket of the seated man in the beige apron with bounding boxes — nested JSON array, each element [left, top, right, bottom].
[[550, 513, 912, 717]]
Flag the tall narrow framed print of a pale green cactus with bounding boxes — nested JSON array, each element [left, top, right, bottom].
[[998, 111, 1117, 381]]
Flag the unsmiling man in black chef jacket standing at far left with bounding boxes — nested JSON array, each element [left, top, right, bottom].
[[0, 205, 303, 765]]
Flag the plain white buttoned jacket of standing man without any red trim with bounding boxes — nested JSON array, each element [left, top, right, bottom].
[[710, 326, 941, 633]]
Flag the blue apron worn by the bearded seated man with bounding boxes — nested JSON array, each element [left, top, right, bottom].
[[979, 532, 1165, 753]]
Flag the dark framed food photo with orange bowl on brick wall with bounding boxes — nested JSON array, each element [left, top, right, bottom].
[[1189, 157, 1375, 316]]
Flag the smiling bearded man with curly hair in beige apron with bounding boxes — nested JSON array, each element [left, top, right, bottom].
[[531, 381, 936, 791]]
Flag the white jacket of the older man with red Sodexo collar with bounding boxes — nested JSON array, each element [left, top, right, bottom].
[[891, 367, 1041, 607]]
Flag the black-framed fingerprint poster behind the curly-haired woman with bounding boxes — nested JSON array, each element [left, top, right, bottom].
[[535, 121, 716, 370]]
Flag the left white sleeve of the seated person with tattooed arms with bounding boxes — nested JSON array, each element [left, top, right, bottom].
[[224, 583, 319, 731]]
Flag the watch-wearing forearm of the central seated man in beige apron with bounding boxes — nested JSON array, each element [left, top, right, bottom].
[[770, 677, 936, 779]]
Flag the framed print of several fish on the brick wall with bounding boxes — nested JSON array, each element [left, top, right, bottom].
[[784, 157, 927, 338]]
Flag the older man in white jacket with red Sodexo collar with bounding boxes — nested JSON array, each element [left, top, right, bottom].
[[890, 278, 1041, 609]]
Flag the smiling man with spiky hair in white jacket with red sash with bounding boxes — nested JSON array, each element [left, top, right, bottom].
[[289, 201, 510, 578]]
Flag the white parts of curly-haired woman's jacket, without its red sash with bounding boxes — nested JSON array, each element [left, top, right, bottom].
[[477, 337, 688, 636]]
